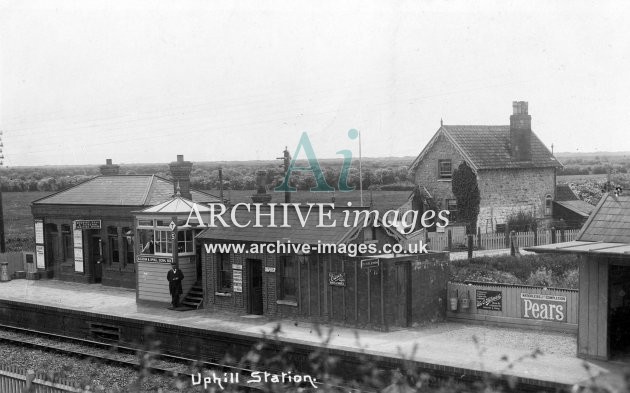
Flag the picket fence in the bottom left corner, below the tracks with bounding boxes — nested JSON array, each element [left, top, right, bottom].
[[0, 366, 85, 393]]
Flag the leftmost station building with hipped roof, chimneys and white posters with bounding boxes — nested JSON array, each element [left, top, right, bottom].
[[31, 155, 219, 288]]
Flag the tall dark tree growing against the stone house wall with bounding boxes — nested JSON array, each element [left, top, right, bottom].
[[451, 161, 481, 234]]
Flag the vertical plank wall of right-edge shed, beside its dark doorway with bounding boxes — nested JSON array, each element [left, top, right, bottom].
[[578, 257, 609, 359]]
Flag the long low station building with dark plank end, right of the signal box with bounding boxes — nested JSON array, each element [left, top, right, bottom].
[[197, 206, 448, 329]]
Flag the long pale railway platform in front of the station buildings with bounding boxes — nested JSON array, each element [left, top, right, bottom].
[[0, 280, 630, 389]]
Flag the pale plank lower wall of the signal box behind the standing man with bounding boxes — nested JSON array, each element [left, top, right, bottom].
[[137, 257, 197, 303]]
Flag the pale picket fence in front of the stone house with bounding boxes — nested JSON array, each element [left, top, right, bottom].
[[426, 229, 580, 251]]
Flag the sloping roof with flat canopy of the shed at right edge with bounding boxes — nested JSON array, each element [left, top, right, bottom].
[[526, 193, 630, 257]]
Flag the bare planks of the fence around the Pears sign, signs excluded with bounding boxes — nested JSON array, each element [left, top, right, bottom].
[[446, 283, 579, 332]]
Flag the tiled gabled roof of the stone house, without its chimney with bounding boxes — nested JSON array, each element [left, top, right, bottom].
[[410, 125, 562, 171]]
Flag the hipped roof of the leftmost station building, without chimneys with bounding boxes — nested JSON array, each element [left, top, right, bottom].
[[33, 175, 219, 206]]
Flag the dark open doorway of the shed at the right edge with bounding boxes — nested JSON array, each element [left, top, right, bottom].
[[608, 265, 630, 359]]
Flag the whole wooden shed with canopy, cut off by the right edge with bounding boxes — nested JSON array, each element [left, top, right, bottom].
[[526, 194, 630, 360]]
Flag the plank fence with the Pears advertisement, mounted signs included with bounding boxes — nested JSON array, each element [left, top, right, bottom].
[[446, 282, 578, 333]]
